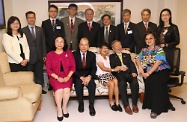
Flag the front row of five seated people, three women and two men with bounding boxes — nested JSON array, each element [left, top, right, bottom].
[[46, 31, 174, 121]]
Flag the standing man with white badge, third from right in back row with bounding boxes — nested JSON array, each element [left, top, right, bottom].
[[117, 9, 135, 53]]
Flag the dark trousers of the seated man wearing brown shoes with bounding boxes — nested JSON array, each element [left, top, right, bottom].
[[117, 75, 139, 106]]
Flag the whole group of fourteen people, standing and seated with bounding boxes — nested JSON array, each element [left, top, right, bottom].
[[2, 4, 180, 121]]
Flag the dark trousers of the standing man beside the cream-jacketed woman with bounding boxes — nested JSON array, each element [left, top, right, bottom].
[[28, 60, 44, 87]]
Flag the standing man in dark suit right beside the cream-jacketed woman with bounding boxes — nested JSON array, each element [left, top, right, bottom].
[[22, 11, 47, 94]]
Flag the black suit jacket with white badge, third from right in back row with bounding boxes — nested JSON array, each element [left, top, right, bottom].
[[117, 22, 135, 53]]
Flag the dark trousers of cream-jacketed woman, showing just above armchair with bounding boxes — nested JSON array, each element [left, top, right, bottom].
[[9, 63, 28, 72]]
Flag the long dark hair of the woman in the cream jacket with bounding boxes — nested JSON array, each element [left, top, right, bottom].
[[7, 16, 23, 37]]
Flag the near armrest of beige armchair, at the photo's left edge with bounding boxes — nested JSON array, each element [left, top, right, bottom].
[[0, 87, 20, 100]]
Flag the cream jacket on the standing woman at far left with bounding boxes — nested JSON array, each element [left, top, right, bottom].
[[2, 33, 30, 64]]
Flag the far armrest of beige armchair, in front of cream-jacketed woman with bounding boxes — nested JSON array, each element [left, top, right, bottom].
[[3, 72, 34, 86]]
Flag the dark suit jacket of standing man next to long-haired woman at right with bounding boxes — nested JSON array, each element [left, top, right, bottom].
[[135, 21, 157, 54]]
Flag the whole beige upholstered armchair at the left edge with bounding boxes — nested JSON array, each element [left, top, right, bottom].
[[0, 52, 42, 122]]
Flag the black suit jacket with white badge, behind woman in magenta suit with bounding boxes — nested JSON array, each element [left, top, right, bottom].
[[42, 19, 65, 53]]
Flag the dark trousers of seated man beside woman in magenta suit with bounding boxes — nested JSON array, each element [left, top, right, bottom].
[[74, 78, 96, 104]]
